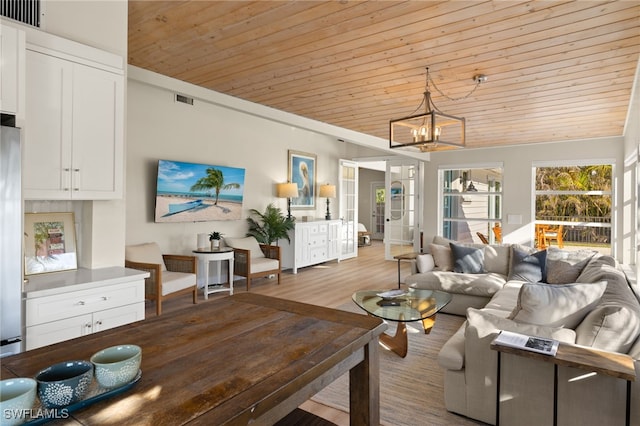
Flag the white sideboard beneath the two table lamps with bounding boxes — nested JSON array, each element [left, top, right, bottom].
[[279, 220, 342, 274]]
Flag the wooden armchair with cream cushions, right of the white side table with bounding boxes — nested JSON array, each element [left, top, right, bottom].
[[225, 237, 282, 291]]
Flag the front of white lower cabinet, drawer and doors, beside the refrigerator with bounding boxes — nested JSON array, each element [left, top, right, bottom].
[[25, 268, 144, 350]]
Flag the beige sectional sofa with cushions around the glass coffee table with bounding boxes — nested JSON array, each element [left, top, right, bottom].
[[405, 238, 640, 426]]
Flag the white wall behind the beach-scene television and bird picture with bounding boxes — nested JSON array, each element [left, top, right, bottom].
[[125, 67, 382, 253]]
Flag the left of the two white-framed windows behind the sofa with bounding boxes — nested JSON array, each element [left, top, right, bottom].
[[439, 166, 502, 243]]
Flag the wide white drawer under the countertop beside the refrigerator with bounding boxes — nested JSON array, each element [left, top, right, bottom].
[[25, 280, 144, 327]]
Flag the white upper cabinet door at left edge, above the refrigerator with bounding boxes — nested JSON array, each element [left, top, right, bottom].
[[0, 25, 25, 117]]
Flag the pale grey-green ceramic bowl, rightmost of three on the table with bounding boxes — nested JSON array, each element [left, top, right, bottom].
[[91, 345, 142, 388]]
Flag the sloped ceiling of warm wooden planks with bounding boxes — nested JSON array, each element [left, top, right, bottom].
[[128, 0, 640, 151]]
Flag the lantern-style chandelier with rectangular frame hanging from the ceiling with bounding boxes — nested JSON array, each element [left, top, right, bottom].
[[389, 67, 487, 152]]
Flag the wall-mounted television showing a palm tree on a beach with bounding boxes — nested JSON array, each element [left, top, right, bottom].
[[155, 160, 245, 222]]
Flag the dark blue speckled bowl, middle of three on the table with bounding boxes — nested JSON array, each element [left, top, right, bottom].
[[36, 361, 93, 408]]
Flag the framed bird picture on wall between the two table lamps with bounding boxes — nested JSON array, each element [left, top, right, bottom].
[[288, 150, 317, 210]]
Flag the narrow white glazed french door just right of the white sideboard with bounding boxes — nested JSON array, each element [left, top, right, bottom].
[[339, 160, 358, 259]]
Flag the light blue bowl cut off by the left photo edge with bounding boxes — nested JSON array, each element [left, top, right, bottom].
[[0, 377, 38, 425]]
